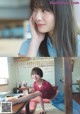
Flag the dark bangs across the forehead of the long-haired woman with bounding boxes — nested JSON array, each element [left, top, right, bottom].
[[30, 0, 55, 12]]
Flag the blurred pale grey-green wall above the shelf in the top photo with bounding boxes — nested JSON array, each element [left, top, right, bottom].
[[0, 0, 30, 19]]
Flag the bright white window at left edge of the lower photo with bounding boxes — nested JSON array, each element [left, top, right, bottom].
[[0, 57, 9, 85]]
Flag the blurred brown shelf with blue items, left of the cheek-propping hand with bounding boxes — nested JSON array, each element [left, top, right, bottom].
[[0, 19, 25, 39]]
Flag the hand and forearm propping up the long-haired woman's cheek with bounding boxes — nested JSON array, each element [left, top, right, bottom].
[[27, 16, 45, 57]]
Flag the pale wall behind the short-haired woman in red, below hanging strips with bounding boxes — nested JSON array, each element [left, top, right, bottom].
[[15, 60, 55, 85]]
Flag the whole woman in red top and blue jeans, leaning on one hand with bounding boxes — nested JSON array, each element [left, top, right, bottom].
[[8, 67, 80, 114]]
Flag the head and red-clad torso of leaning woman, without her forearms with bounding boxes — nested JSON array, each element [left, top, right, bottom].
[[31, 67, 56, 99]]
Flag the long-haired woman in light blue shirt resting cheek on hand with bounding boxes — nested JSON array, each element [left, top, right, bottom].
[[19, 0, 80, 57]]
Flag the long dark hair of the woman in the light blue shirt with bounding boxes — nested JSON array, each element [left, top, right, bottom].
[[30, 0, 78, 57]]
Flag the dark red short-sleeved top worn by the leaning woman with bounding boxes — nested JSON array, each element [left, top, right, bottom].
[[34, 80, 56, 99]]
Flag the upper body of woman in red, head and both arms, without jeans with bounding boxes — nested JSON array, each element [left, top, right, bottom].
[[9, 67, 56, 114]]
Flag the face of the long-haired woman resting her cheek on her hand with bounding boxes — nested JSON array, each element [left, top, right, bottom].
[[32, 8, 55, 33]]
